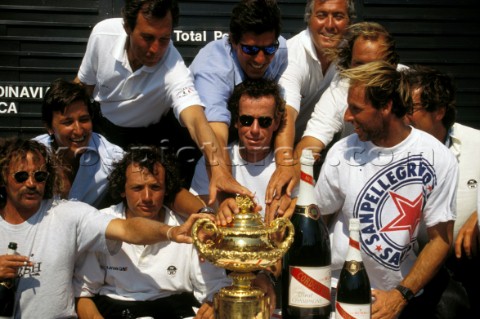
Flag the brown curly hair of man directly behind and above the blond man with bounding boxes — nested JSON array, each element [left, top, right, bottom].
[[336, 22, 400, 70]]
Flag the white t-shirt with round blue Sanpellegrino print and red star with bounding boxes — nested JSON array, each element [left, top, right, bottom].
[[315, 128, 458, 290]]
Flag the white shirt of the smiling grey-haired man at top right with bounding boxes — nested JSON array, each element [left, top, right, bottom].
[[278, 28, 337, 141]]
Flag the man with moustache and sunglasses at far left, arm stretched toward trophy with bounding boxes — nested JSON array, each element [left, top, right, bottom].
[[0, 138, 212, 318]]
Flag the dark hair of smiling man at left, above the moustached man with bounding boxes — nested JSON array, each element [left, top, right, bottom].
[[42, 78, 93, 128]]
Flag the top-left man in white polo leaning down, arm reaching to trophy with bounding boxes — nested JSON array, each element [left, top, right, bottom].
[[75, 0, 252, 202]]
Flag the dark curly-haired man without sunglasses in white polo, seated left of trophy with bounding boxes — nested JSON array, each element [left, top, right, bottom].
[[74, 147, 273, 319]]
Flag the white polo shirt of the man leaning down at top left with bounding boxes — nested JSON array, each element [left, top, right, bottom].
[[78, 18, 203, 127]]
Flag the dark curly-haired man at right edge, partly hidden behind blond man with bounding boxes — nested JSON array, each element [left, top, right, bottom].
[[405, 66, 480, 318]]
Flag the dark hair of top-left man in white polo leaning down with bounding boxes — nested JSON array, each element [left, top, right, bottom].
[[122, 0, 180, 30]]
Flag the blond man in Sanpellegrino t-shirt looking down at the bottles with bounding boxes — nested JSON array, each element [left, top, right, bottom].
[[316, 61, 458, 318]]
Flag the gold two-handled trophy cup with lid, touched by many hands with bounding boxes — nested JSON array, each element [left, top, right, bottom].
[[192, 196, 294, 319]]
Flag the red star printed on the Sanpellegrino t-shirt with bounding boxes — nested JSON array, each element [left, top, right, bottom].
[[380, 192, 423, 238]]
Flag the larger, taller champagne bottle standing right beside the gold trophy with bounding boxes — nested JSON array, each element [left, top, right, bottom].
[[282, 150, 331, 319]]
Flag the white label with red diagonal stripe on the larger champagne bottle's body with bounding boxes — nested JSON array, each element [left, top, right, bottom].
[[288, 266, 331, 308]]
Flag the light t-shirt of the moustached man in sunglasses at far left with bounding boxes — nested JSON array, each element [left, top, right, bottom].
[[0, 200, 121, 318]]
